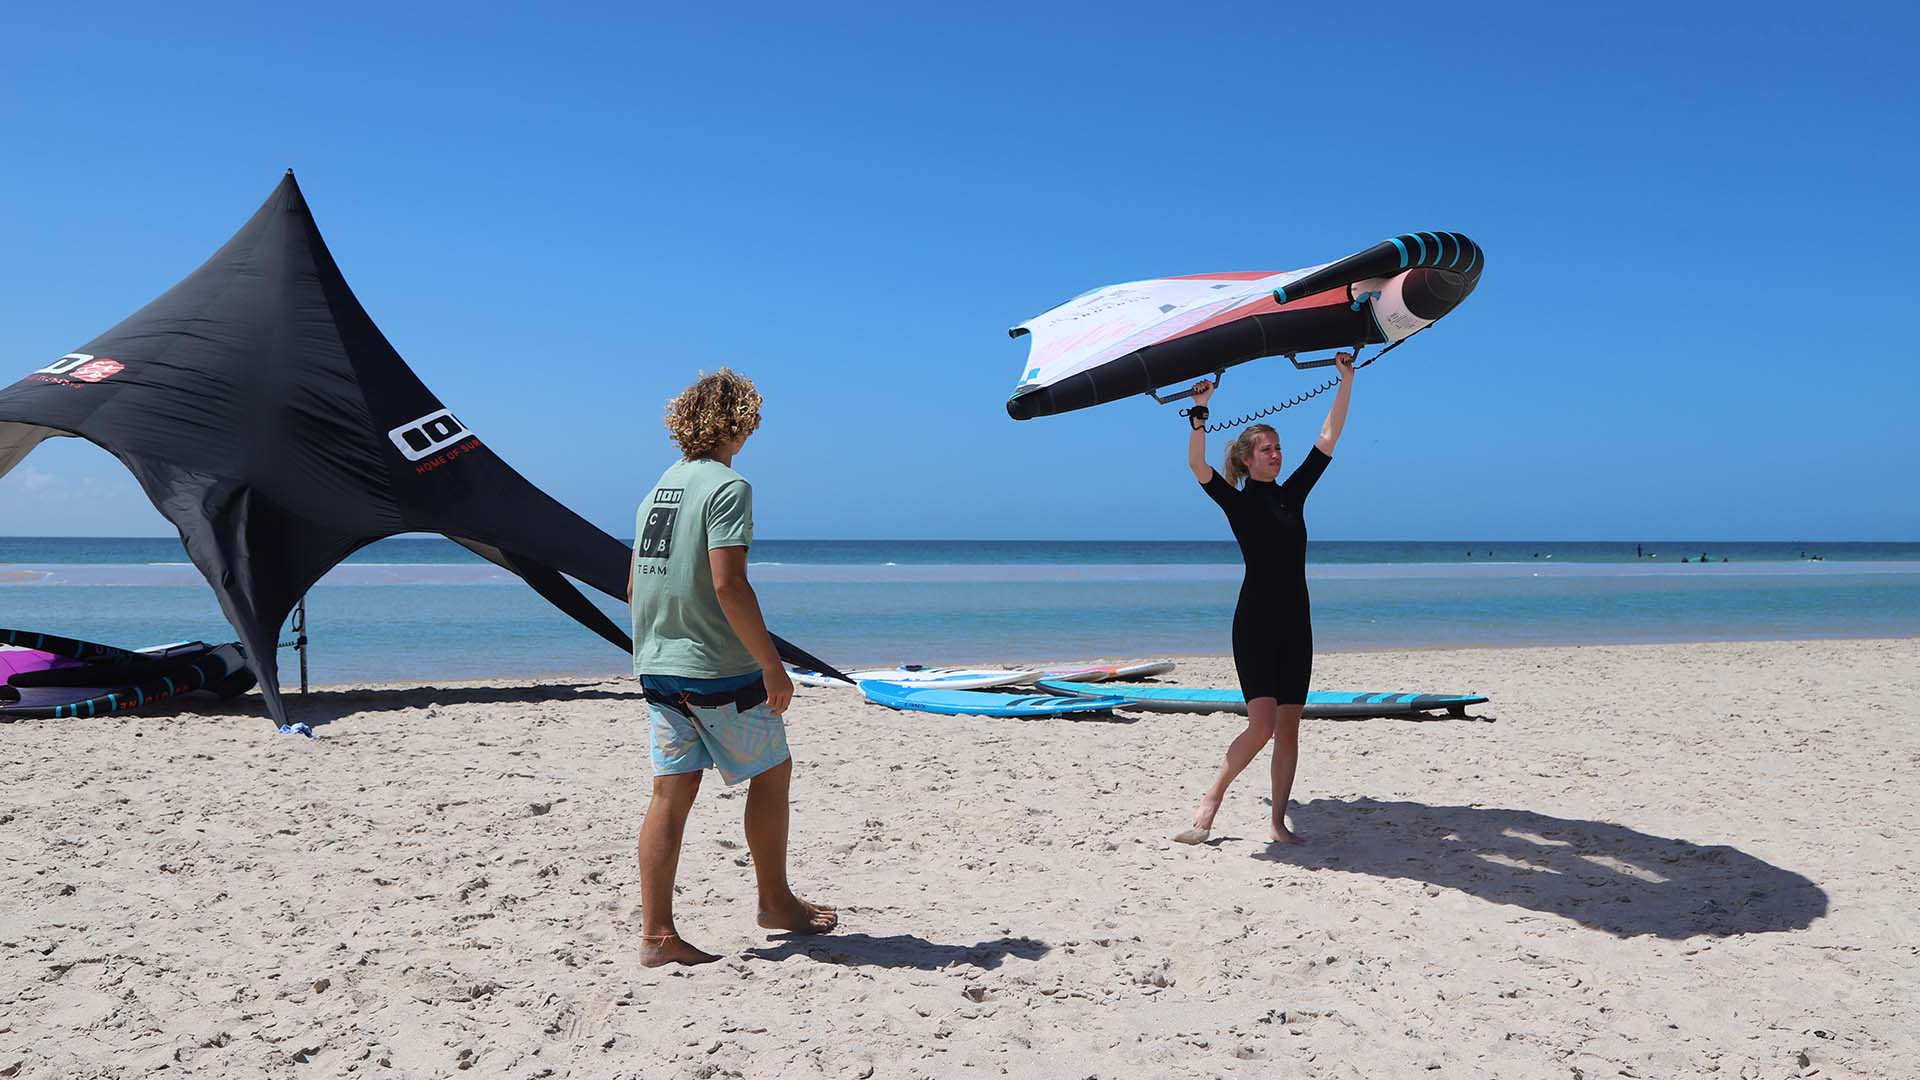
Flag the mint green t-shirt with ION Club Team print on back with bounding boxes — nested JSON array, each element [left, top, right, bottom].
[[634, 457, 760, 678]]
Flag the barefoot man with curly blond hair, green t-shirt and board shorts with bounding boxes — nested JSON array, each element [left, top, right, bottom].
[[626, 367, 839, 967]]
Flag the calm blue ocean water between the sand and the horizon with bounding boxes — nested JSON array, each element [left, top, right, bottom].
[[0, 538, 1920, 686]]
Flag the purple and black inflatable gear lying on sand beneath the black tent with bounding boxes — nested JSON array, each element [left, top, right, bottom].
[[0, 630, 253, 723]]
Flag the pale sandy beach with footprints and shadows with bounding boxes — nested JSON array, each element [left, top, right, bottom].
[[0, 640, 1920, 1080]]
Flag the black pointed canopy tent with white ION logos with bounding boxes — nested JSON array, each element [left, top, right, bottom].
[[0, 171, 831, 723]]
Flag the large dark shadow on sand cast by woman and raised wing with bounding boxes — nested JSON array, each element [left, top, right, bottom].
[[1254, 799, 1828, 940]]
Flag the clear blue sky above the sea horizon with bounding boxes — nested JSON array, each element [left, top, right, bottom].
[[0, 4, 1920, 540]]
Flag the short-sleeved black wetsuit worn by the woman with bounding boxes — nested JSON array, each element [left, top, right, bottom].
[[1202, 446, 1332, 705]]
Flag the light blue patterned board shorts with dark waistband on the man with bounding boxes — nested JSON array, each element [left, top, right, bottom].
[[639, 671, 791, 784]]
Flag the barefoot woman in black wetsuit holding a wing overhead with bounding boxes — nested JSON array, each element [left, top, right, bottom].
[[1175, 354, 1354, 844]]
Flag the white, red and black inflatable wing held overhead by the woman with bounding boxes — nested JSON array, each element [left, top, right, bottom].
[[1006, 233, 1486, 421]]
